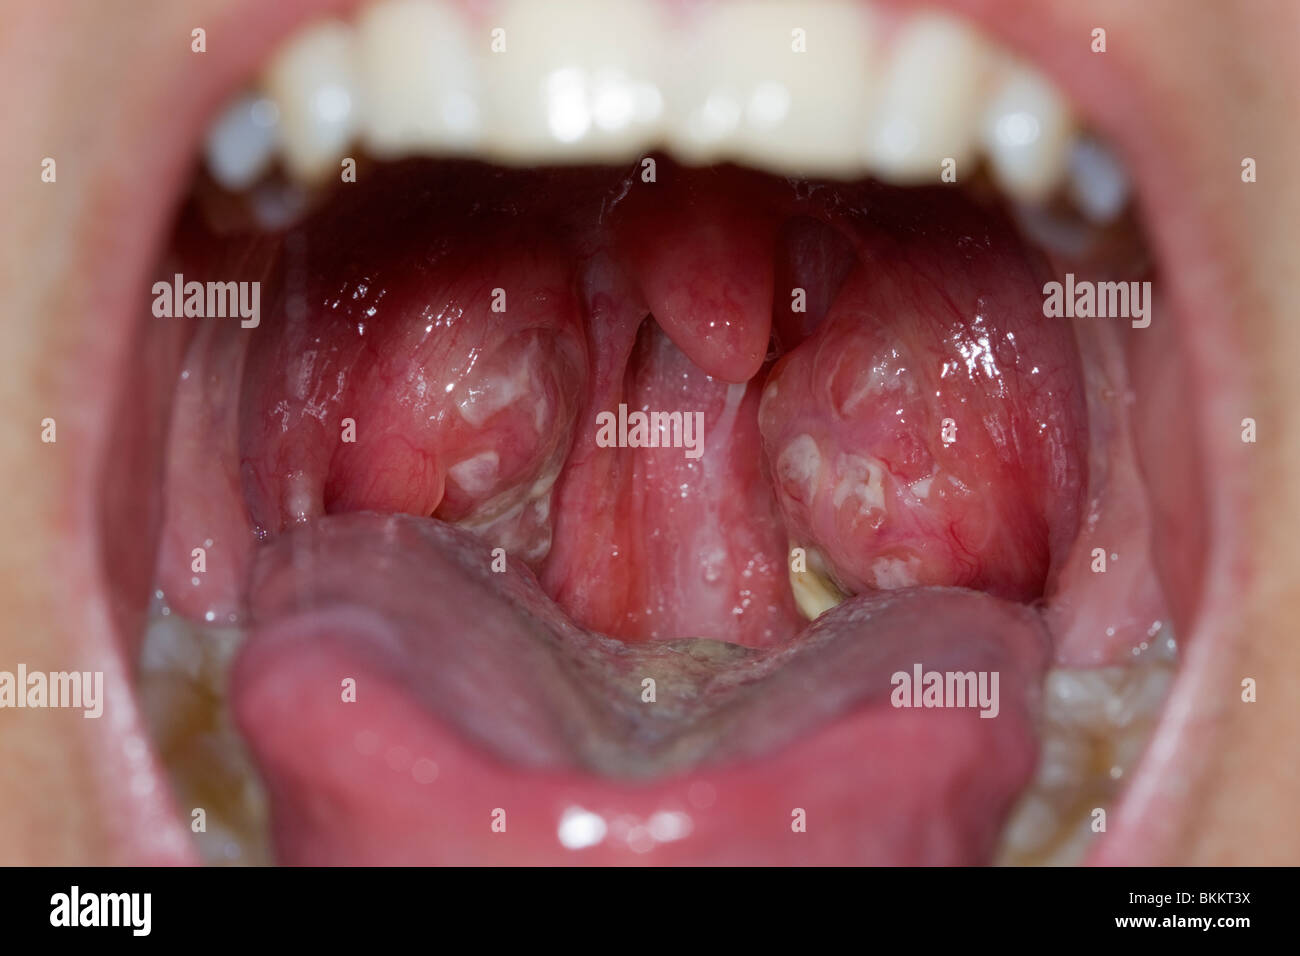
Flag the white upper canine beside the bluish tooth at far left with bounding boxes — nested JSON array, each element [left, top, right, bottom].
[[264, 21, 358, 179]]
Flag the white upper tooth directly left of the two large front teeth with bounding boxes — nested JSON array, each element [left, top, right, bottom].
[[358, 0, 486, 159]]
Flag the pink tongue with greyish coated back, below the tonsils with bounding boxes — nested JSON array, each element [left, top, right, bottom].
[[231, 514, 1048, 864]]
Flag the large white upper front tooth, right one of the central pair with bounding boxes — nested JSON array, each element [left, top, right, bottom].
[[670, 0, 878, 176]]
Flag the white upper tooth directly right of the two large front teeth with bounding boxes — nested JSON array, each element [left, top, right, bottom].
[[866, 13, 989, 182]]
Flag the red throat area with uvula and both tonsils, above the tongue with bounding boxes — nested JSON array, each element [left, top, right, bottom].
[[163, 160, 1087, 646]]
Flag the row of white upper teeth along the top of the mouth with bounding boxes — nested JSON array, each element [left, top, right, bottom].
[[208, 0, 1118, 215]]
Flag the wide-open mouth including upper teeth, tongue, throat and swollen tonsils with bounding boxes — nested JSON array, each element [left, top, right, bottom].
[[78, 0, 1237, 864]]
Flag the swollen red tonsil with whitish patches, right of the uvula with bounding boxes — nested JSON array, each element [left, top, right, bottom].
[[762, 250, 1087, 601]]
